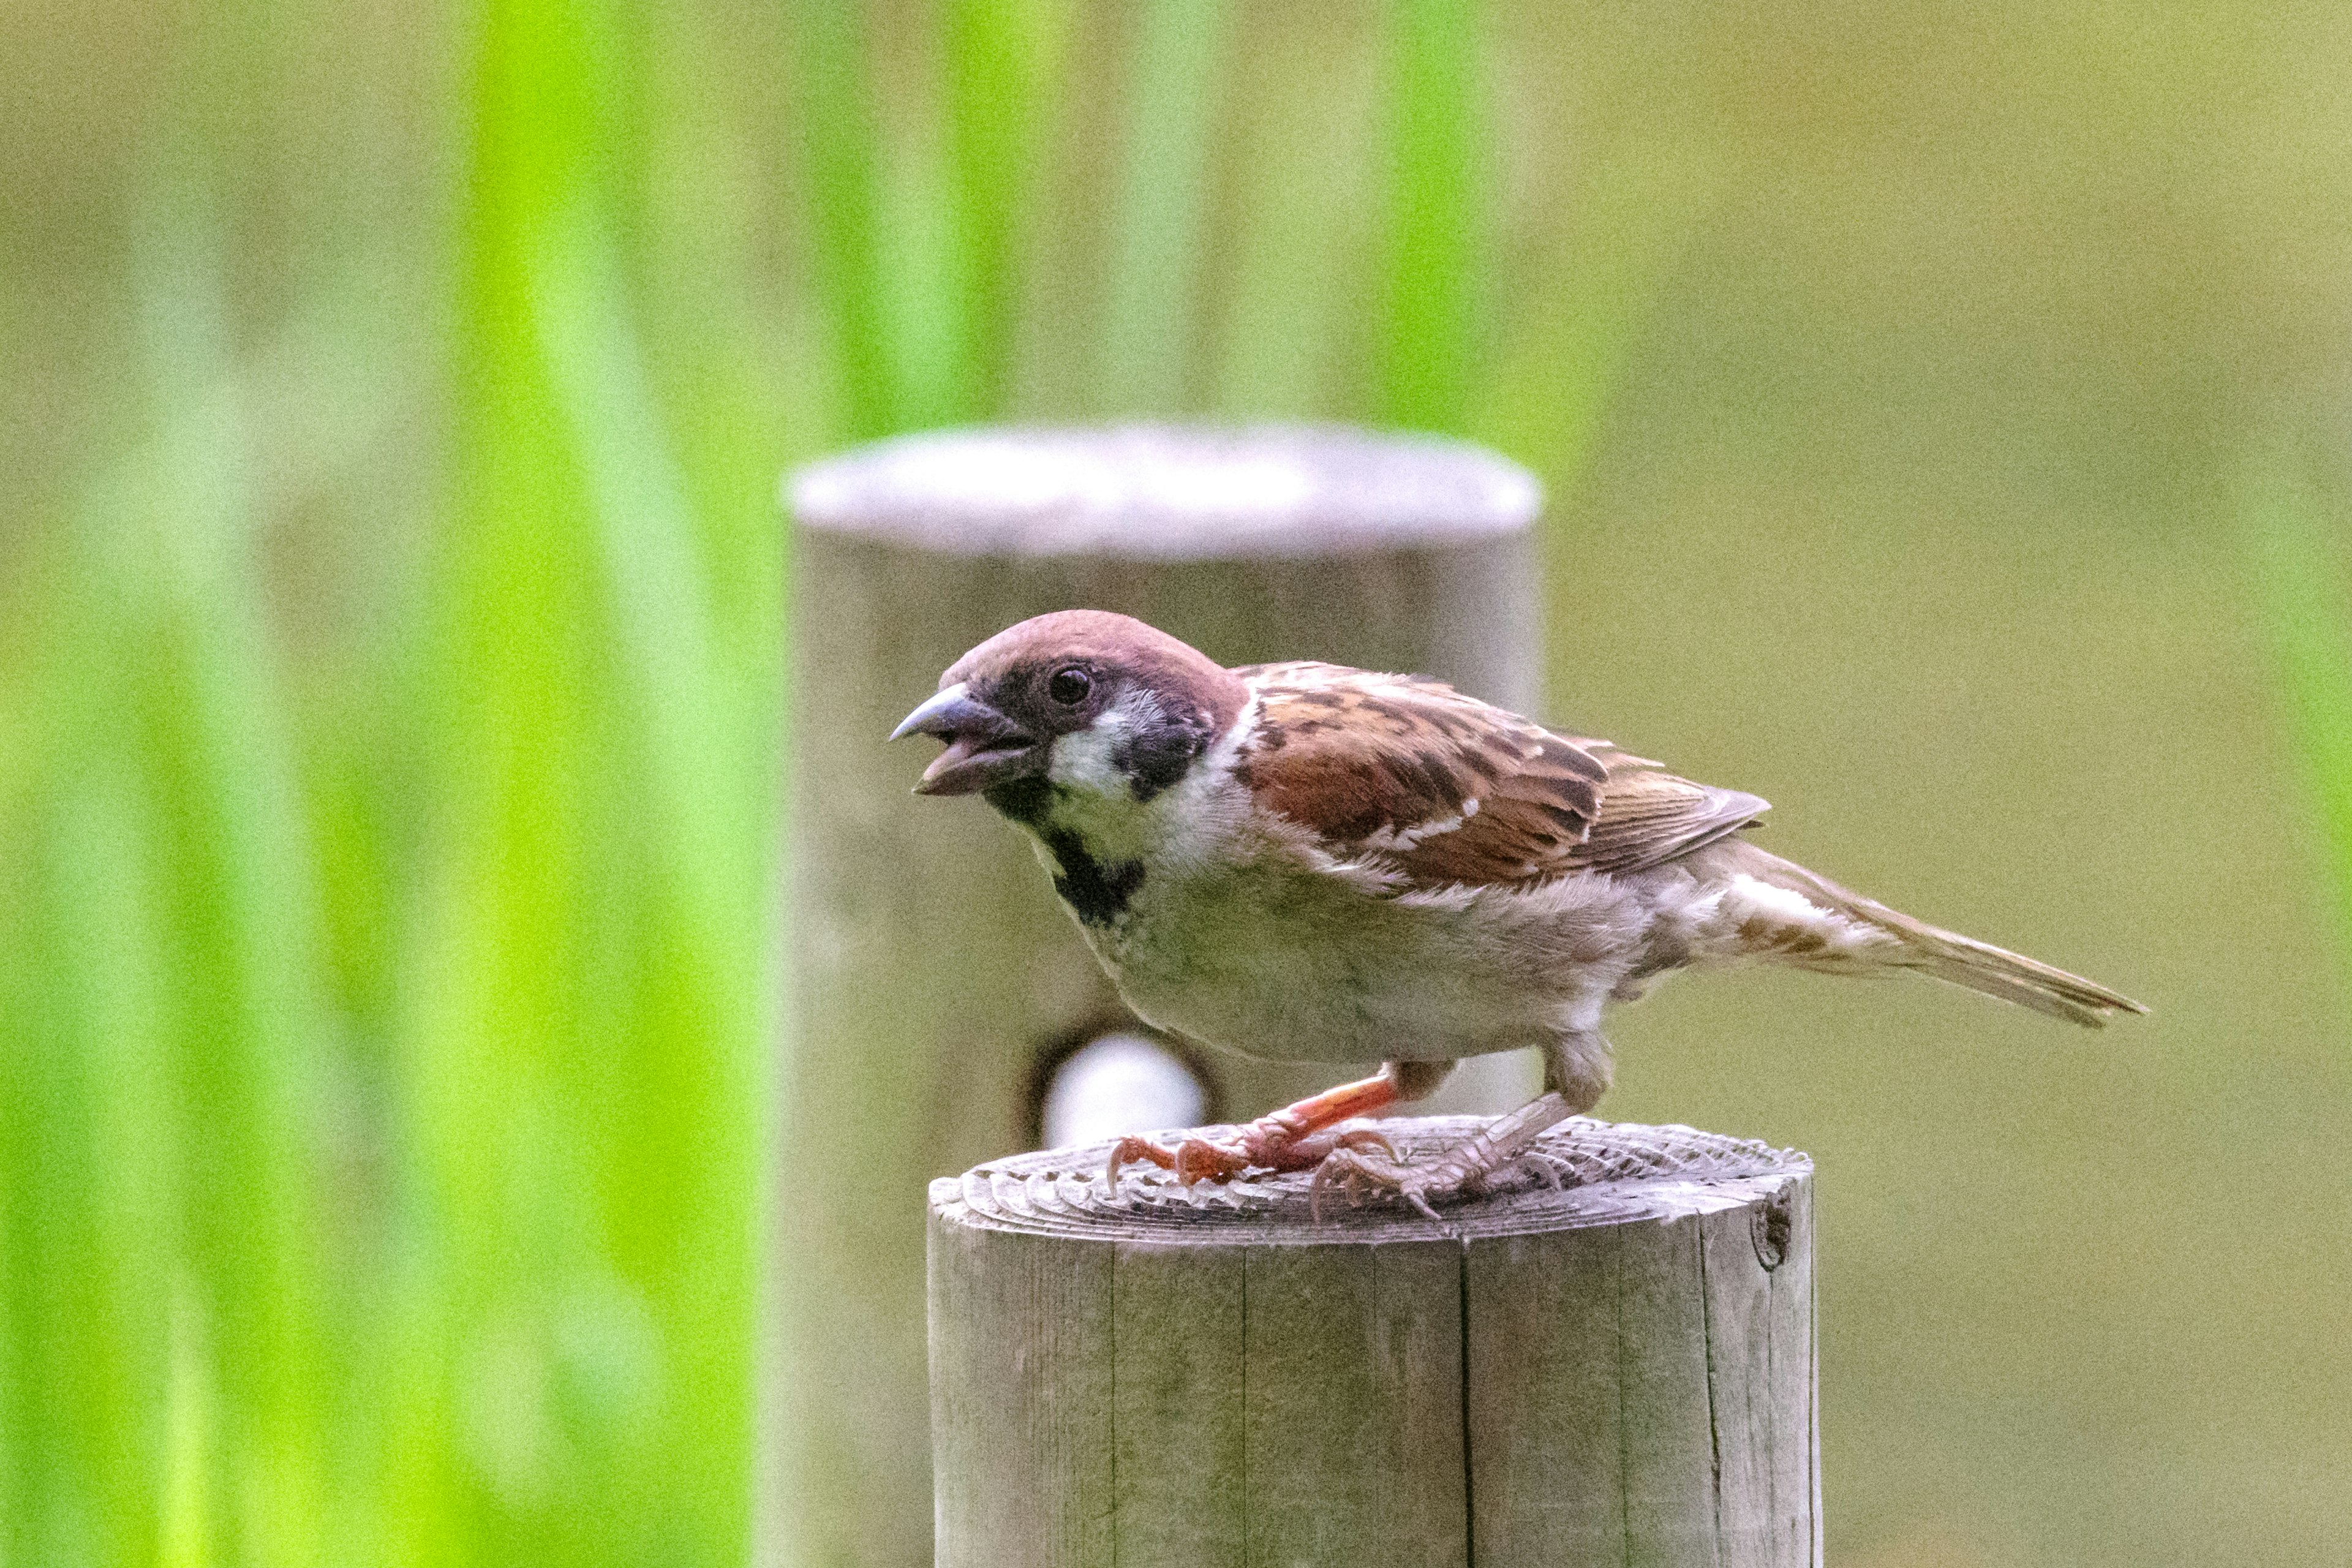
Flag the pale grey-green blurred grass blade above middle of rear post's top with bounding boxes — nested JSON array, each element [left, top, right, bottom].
[[1096, 0, 1232, 416]]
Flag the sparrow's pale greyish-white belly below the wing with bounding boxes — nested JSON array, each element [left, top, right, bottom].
[[1087, 863, 1566, 1063]]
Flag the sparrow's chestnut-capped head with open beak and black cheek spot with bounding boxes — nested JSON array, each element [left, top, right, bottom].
[[891, 609, 1249, 816]]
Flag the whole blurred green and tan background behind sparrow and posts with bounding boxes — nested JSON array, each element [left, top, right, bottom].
[[0, 0, 2352, 1568]]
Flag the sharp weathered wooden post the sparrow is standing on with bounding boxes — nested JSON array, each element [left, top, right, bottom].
[[932, 1117, 1820, 1568]]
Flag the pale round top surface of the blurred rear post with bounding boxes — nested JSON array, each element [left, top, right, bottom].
[[786, 426, 1543, 559]]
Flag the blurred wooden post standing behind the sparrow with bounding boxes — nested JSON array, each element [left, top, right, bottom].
[[776, 428, 1540, 1568]]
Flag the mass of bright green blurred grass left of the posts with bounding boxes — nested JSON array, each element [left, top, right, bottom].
[[0, 2, 781, 1563]]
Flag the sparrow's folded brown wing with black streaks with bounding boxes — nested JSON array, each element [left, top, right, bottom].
[[1235, 663, 1764, 889]]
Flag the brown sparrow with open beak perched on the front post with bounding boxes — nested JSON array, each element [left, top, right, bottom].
[[891, 609, 2147, 1218]]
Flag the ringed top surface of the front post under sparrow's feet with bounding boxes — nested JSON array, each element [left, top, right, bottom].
[[932, 1117, 1814, 1262]]
